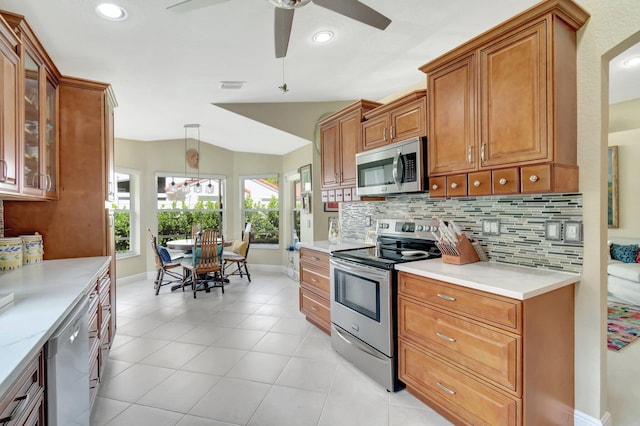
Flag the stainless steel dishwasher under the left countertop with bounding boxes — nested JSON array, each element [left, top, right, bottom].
[[45, 296, 90, 426]]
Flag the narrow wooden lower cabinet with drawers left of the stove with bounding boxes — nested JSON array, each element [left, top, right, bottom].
[[300, 247, 331, 334]]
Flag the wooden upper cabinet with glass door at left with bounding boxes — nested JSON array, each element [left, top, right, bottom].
[[0, 11, 60, 199]]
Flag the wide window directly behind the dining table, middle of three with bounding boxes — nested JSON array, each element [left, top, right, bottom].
[[157, 176, 225, 245]]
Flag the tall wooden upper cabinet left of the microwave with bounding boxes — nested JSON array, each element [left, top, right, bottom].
[[318, 100, 380, 189]]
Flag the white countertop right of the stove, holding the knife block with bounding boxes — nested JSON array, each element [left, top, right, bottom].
[[396, 259, 580, 300]]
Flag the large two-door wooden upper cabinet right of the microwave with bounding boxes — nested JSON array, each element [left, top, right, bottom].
[[420, 0, 589, 196]]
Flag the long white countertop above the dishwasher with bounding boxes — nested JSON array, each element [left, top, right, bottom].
[[0, 256, 111, 397]]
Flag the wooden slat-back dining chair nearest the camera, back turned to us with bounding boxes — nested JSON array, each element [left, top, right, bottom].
[[182, 229, 224, 299]]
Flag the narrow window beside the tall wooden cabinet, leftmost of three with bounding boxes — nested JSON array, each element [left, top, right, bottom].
[[112, 172, 138, 257]]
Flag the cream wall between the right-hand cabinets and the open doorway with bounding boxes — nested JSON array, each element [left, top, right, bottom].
[[575, 0, 640, 419]]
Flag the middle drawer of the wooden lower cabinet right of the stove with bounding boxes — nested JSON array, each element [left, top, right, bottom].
[[398, 297, 522, 396]]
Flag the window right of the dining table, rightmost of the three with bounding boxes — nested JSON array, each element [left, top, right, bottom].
[[240, 175, 280, 245]]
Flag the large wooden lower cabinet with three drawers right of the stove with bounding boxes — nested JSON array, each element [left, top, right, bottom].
[[398, 272, 574, 425]]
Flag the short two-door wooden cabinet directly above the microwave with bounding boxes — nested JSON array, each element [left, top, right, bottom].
[[362, 90, 427, 151]]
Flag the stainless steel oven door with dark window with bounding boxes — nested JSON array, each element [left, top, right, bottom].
[[331, 258, 394, 357]]
